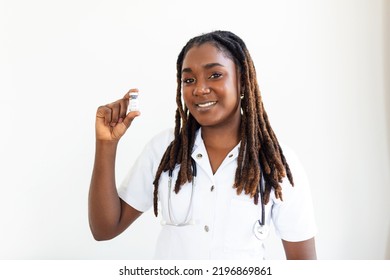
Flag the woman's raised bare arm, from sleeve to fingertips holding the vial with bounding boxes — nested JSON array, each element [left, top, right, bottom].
[[88, 89, 142, 240]]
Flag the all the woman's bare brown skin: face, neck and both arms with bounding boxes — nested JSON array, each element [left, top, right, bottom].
[[88, 43, 316, 259]]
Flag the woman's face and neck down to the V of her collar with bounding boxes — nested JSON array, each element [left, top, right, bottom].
[[182, 44, 241, 173]]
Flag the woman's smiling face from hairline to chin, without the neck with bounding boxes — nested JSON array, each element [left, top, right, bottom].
[[181, 43, 240, 127]]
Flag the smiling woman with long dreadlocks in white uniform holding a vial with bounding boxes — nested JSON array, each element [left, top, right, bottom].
[[89, 31, 316, 259]]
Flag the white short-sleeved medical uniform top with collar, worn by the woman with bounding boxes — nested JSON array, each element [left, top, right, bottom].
[[119, 129, 316, 259]]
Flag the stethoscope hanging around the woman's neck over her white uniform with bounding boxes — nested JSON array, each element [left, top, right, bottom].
[[162, 158, 269, 240]]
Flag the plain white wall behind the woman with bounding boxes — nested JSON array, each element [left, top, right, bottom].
[[0, 0, 390, 259]]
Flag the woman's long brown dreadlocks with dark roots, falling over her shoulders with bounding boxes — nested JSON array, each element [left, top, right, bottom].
[[153, 31, 294, 216]]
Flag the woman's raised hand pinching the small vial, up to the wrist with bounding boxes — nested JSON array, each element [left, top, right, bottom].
[[96, 89, 140, 141]]
